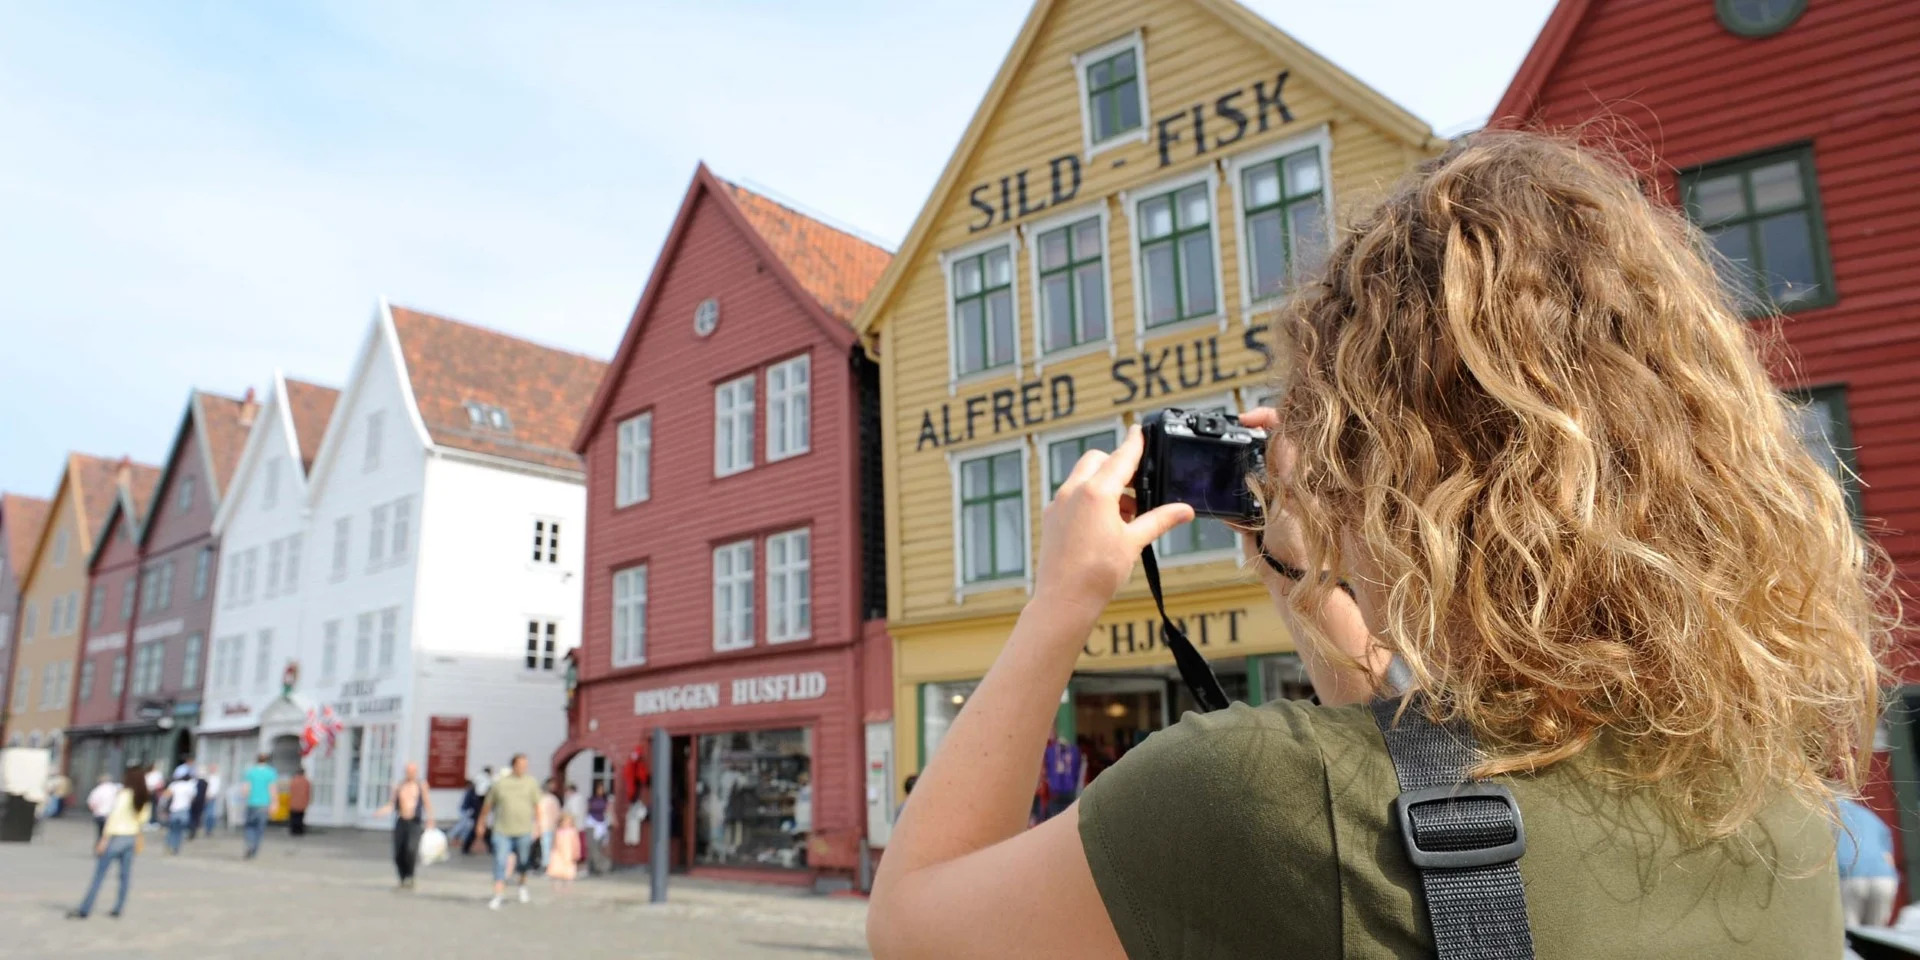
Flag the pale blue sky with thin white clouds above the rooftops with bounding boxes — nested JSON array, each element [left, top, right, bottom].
[[0, 0, 1551, 495]]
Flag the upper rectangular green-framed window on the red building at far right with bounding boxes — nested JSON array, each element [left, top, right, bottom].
[[1680, 146, 1834, 313]]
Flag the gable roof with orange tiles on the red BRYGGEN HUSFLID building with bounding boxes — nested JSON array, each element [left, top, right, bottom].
[[572, 163, 893, 453]]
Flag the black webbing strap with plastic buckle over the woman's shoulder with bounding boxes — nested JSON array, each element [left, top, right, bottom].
[[1371, 693, 1534, 960]]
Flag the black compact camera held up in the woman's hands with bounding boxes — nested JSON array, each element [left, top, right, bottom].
[[1133, 407, 1267, 524]]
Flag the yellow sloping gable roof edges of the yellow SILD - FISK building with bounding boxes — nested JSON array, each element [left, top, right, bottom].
[[854, 0, 1434, 340]]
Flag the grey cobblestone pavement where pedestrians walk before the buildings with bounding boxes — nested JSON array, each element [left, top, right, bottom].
[[0, 818, 868, 960]]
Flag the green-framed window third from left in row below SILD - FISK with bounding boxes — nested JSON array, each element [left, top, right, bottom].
[[1139, 182, 1219, 326]]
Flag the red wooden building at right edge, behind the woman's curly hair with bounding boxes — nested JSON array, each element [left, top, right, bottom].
[[1494, 0, 1920, 877]]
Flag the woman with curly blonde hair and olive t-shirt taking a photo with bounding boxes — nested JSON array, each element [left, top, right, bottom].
[[868, 132, 1897, 960]]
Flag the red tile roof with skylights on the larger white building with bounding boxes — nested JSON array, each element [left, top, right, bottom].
[[392, 307, 607, 470]]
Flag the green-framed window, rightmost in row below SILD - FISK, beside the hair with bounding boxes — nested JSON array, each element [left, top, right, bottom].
[[1240, 146, 1327, 300]]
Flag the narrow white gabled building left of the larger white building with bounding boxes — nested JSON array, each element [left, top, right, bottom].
[[194, 372, 340, 802]]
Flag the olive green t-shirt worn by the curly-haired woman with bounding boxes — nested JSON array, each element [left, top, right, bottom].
[[1079, 703, 1843, 960]]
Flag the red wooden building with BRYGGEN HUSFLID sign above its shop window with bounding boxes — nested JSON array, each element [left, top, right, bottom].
[[555, 165, 893, 881]]
